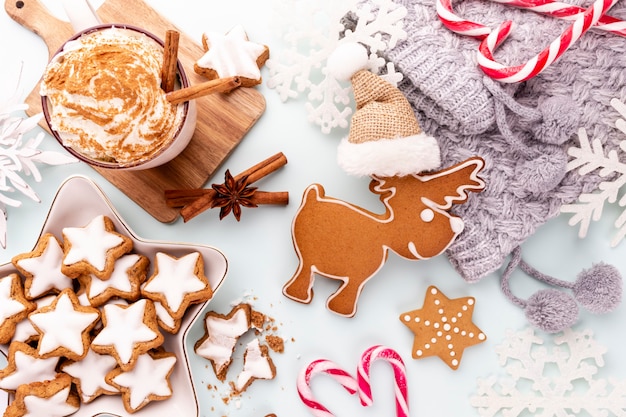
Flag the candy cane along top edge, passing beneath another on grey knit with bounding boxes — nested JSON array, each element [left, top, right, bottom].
[[435, 0, 626, 40]]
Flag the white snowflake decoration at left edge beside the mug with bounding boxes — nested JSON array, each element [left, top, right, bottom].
[[0, 98, 76, 248]]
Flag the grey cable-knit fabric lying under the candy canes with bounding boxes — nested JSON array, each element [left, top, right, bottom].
[[346, 0, 626, 282]]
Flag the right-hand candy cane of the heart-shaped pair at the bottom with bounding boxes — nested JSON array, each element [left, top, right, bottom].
[[357, 345, 409, 417]]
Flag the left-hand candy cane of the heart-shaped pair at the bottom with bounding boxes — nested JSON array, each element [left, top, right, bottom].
[[297, 359, 359, 417]]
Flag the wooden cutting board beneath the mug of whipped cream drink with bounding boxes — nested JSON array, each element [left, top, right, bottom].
[[5, 0, 265, 223]]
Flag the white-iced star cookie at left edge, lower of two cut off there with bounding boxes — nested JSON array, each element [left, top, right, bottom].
[[0, 342, 59, 392]]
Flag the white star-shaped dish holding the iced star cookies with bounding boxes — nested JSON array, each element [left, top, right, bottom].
[[0, 176, 228, 417]]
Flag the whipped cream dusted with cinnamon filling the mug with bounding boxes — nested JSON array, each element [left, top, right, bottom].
[[40, 27, 184, 164]]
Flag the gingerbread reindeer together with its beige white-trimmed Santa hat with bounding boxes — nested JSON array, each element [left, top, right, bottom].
[[283, 44, 485, 317]]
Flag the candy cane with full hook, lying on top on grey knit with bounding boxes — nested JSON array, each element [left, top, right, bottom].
[[477, 0, 618, 83]]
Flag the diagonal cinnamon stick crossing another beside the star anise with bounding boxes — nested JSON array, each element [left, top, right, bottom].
[[176, 152, 287, 222]]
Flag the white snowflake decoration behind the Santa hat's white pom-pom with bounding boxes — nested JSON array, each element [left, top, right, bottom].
[[265, 0, 407, 133]]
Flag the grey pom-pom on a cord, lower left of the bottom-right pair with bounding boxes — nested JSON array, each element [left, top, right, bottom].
[[524, 288, 578, 333]]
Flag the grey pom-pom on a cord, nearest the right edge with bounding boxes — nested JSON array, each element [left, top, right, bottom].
[[572, 263, 622, 314]]
